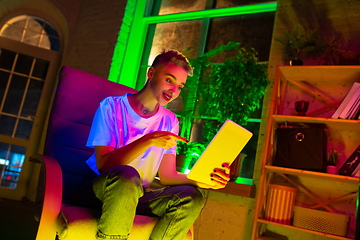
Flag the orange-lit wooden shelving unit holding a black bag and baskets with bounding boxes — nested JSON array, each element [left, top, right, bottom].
[[251, 66, 360, 240]]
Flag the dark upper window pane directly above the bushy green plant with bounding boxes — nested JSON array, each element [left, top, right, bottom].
[[206, 12, 275, 63]]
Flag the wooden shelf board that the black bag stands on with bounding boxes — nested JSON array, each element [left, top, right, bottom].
[[265, 165, 359, 184]]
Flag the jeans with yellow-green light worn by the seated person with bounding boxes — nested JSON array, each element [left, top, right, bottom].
[[76, 165, 204, 240]]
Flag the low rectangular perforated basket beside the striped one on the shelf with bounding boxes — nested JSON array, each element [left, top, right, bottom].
[[293, 206, 349, 236]]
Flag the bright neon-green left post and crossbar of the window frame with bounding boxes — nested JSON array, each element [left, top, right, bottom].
[[109, 0, 277, 88]]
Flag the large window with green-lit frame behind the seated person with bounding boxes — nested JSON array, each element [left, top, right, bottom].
[[109, 0, 276, 178]]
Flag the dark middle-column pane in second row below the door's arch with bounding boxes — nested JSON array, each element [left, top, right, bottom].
[[3, 74, 27, 115]]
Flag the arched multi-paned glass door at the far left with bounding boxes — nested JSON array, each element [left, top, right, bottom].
[[0, 15, 60, 189]]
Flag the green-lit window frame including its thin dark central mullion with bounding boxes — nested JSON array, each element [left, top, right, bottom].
[[108, 0, 277, 90]]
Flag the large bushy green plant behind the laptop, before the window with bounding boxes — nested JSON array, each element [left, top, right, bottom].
[[199, 44, 268, 147]]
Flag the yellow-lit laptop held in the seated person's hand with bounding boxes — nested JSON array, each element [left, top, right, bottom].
[[187, 119, 253, 186]]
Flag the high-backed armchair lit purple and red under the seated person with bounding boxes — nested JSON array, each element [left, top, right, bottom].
[[30, 66, 193, 240]]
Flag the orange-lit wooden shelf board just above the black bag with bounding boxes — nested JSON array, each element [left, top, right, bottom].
[[273, 115, 360, 131]]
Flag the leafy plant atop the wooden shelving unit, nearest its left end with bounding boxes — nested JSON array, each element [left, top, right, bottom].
[[275, 24, 328, 65]]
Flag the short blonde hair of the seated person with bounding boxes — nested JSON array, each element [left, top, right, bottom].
[[151, 50, 193, 76]]
